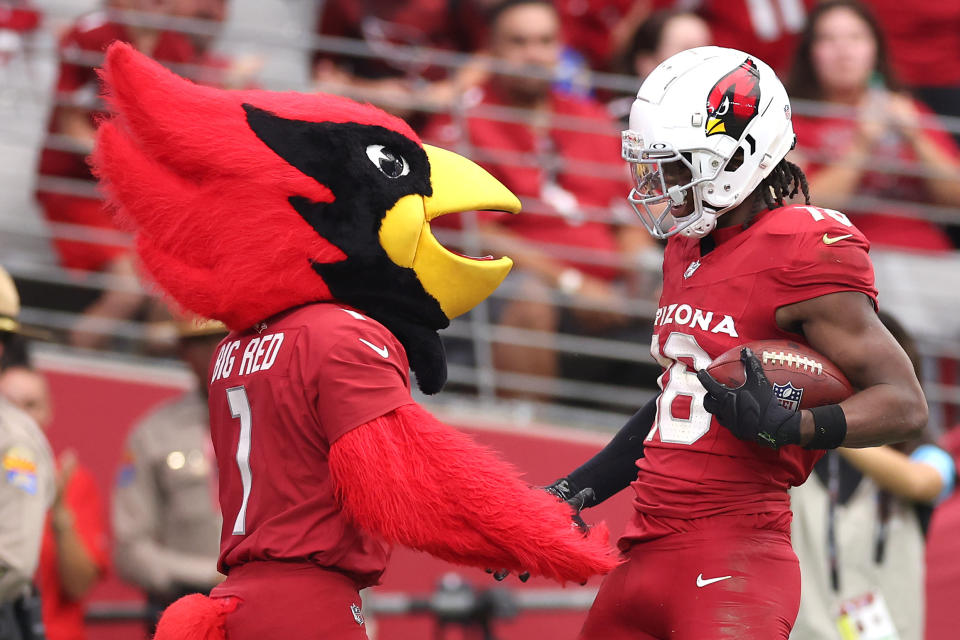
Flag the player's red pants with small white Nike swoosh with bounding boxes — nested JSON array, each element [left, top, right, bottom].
[[579, 529, 800, 640]]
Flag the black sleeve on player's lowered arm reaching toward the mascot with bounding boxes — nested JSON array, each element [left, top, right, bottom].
[[555, 395, 660, 507]]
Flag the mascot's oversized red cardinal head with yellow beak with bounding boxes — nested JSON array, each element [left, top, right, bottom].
[[92, 43, 520, 393]]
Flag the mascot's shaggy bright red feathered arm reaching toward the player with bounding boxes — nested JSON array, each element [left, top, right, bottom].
[[330, 404, 617, 582]]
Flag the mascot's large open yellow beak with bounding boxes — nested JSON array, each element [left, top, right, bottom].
[[380, 144, 520, 319]]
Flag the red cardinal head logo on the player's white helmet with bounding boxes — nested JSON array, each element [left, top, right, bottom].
[[706, 58, 760, 140]]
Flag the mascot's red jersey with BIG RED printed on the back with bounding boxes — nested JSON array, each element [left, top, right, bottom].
[[209, 302, 413, 587]]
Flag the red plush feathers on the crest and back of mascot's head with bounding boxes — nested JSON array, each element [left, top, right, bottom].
[[93, 43, 419, 329]]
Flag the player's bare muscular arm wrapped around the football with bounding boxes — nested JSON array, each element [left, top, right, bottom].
[[776, 291, 927, 447]]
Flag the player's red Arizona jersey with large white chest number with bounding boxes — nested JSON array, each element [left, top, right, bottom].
[[625, 206, 877, 539]]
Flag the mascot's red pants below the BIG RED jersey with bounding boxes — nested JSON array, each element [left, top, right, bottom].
[[210, 562, 367, 640]]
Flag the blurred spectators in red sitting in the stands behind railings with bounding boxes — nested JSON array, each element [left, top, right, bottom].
[[7, 0, 960, 399]]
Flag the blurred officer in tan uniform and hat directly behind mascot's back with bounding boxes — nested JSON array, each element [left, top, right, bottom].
[[112, 320, 226, 630]]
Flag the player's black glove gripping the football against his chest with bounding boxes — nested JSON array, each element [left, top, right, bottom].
[[697, 347, 800, 449]]
